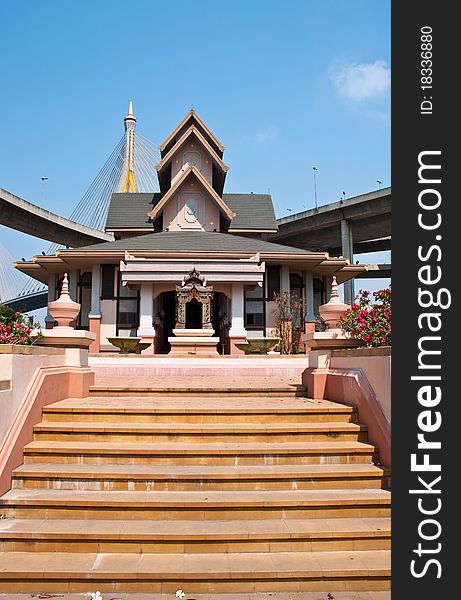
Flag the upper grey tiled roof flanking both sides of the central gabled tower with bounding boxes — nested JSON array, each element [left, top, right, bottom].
[[106, 193, 277, 233]]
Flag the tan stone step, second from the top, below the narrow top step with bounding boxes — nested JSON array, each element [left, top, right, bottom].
[[43, 396, 357, 425]]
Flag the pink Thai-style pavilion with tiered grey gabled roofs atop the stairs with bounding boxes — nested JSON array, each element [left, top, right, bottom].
[[17, 110, 364, 354]]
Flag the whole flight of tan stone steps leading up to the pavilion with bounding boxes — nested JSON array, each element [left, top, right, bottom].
[[0, 382, 390, 594]]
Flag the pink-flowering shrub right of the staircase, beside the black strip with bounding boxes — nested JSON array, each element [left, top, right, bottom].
[[339, 286, 391, 347]]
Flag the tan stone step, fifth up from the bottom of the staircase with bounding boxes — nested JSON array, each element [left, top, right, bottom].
[[24, 439, 376, 466]]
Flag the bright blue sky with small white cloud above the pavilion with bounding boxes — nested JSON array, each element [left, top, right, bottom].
[[0, 0, 390, 298]]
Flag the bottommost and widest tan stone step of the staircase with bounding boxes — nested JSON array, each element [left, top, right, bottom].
[[0, 550, 390, 594]]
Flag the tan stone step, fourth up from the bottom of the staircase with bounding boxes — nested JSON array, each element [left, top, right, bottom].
[[13, 463, 386, 492]]
